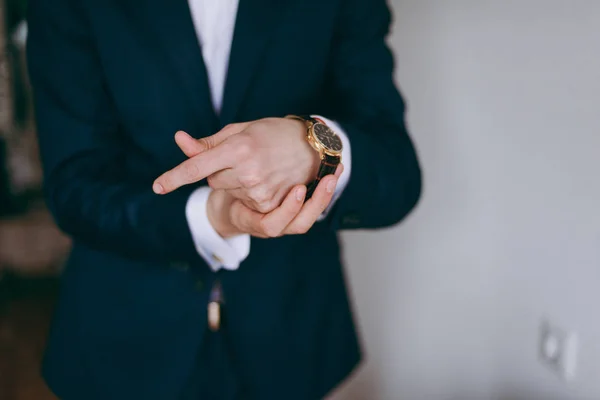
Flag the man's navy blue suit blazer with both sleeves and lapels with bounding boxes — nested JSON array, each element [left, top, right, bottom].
[[28, 0, 421, 400]]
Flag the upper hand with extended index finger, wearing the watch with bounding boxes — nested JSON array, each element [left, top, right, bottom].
[[153, 118, 319, 213]]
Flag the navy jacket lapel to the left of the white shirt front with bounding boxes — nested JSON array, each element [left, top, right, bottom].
[[139, 0, 219, 132]]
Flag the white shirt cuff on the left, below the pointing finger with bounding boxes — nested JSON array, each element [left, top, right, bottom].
[[185, 186, 250, 271]]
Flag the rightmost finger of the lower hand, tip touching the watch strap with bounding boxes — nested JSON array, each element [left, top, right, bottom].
[[284, 171, 341, 235]]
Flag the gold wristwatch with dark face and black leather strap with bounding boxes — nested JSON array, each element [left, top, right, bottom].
[[286, 115, 343, 201]]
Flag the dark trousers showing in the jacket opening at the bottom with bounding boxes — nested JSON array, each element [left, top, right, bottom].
[[180, 326, 246, 400]]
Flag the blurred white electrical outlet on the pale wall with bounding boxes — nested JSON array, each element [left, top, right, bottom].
[[539, 321, 579, 381]]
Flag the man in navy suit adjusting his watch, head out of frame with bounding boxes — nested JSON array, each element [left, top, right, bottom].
[[28, 0, 421, 400]]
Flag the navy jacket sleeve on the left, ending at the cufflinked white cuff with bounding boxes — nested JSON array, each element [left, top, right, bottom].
[[27, 0, 199, 261]]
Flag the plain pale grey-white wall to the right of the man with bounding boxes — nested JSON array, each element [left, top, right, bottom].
[[334, 0, 600, 400]]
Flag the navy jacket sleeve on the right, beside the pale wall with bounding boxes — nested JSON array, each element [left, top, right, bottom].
[[327, 0, 421, 229]]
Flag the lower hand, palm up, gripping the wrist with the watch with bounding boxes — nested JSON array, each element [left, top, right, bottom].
[[207, 165, 343, 238]]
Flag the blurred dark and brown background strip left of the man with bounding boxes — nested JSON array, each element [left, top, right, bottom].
[[0, 0, 70, 400]]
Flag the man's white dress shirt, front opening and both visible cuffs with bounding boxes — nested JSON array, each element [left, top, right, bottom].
[[185, 0, 351, 271]]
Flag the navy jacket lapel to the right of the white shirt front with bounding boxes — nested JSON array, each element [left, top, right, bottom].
[[219, 0, 286, 125]]
